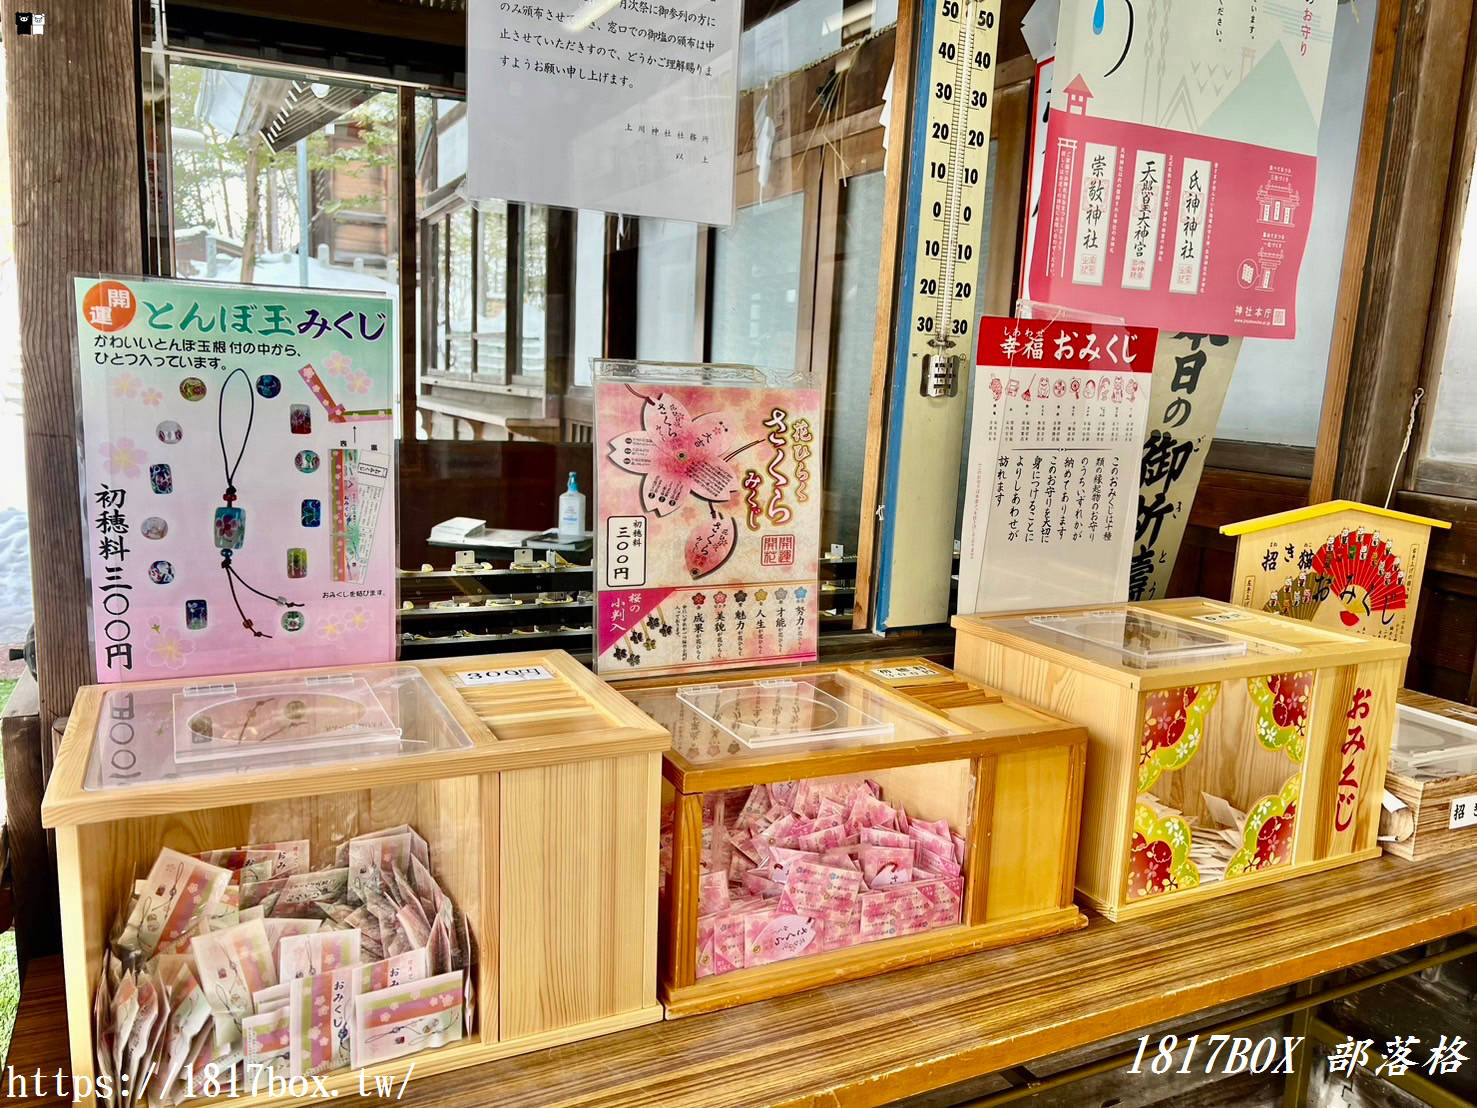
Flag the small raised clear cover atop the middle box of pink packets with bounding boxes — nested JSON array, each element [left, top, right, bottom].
[[676, 678, 894, 746]]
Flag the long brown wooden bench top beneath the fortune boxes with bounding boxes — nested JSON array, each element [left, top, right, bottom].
[[9, 854, 1477, 1108]]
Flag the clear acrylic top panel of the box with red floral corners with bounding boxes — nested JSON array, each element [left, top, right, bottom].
[[1001, 609, 1250, 669]]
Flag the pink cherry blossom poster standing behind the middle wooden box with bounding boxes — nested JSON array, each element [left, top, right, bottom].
[[595, 363, 821, 674]]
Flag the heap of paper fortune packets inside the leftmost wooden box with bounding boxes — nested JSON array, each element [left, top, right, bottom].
[[93, 827, 469, 1105]]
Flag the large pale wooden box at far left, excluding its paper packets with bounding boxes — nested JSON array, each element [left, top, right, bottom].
[[43, 652, 669, 1102]]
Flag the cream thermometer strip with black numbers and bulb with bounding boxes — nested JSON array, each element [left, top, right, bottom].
[[908, 0, 1000, 397]]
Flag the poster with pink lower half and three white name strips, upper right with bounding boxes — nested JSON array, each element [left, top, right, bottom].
[[1029, 0, 1337, 338]]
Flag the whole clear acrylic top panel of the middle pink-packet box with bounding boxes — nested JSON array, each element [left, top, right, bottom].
[[623, 672, 956, 770]]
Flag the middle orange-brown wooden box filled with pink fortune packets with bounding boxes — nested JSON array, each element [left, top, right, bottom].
[[622, 659, 1087, 1016]]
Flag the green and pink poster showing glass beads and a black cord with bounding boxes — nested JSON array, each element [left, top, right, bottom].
[[74, 278, 399, 683]]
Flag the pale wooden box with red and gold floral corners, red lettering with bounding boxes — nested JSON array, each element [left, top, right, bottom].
[[954, 600, 1409, 920]]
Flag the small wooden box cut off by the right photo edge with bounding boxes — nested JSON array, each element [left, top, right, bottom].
[[1380, 688, 1477, 861]]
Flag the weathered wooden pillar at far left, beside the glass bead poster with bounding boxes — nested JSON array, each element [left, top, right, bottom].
[[0, 0, 143, 729]]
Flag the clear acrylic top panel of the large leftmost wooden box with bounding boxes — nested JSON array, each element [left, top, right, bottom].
[[83, 666, 473, 790]]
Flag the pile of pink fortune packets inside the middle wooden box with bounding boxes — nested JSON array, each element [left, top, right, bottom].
[[685, 776, 964, 978]]
